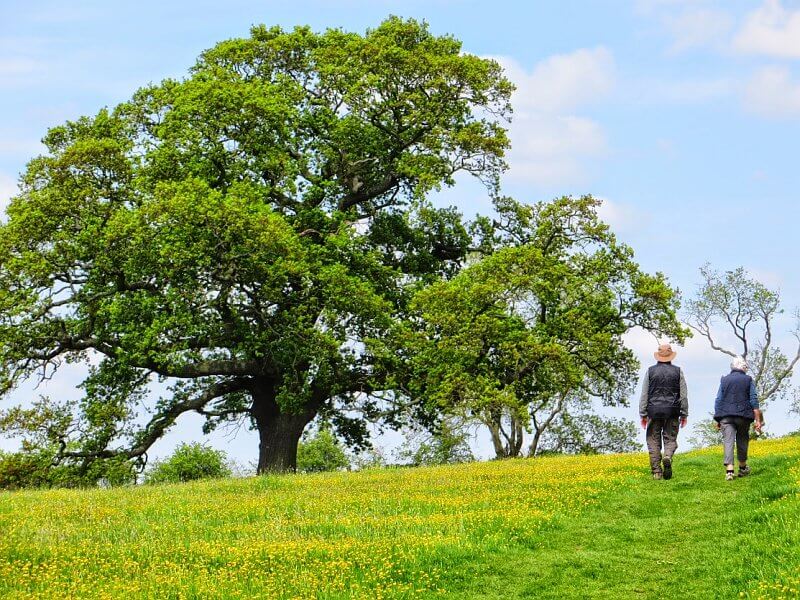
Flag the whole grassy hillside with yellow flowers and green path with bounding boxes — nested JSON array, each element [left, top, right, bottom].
[[0, 438, 800, 599]]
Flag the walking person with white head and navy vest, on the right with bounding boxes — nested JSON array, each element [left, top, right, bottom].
[[714, 356, 764, 481]]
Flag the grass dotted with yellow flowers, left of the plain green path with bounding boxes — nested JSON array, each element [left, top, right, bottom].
[[0, 455, 643, 598]]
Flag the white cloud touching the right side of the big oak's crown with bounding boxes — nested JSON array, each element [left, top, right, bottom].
[[496, 48, 615, 185]]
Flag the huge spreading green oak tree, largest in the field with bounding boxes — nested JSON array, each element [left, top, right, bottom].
[[0, 17, 512, 472]]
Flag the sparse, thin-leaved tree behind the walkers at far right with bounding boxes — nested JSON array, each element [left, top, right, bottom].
[[687, 264, 800, 409]]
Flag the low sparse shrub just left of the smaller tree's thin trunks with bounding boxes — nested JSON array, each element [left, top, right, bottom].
[[397, 420, 475, 467]]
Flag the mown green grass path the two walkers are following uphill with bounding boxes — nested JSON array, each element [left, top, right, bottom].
[[446, 446, 800, 599]]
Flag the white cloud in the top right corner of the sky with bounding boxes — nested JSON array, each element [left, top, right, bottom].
[[733, 0, 800, 58]]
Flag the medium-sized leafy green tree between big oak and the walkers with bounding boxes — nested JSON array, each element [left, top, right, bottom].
[[400, 196, 686, 457]]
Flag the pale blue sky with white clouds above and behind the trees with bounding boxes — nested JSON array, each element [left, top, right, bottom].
[[0, 0, 800, 462]]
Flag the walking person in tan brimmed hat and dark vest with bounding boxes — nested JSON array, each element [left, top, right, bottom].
[[639, 344, 689, 479]]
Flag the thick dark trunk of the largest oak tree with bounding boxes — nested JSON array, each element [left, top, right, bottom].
[[252, 380, 317, 475]]
